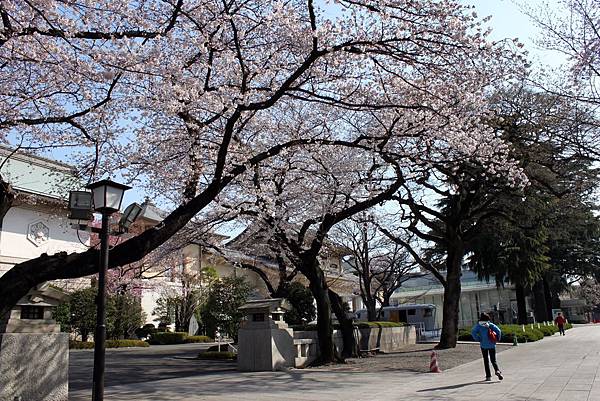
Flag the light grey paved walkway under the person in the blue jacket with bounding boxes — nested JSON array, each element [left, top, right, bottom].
[[69, 326, 600, 401]]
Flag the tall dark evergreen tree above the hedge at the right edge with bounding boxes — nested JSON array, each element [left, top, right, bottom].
[[470, 87, 600, 323]]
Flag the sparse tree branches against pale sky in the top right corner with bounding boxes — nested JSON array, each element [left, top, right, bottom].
[[524, 0, 600, 161]]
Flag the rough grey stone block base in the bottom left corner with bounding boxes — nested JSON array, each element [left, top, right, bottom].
[[0, 333, 69, 401]]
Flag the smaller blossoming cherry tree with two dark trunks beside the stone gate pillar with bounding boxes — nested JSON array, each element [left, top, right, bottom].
[[231, 143, 403, 362]]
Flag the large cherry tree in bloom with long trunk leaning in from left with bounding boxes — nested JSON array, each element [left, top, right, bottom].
[[0, 0, 519, 349]]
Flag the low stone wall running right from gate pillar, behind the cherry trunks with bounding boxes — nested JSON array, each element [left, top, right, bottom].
[[294, 326, 417, 368]]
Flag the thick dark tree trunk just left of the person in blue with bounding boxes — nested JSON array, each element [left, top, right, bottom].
[[436, 242, 464, 349]]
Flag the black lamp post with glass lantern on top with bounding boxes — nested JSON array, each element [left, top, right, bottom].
[[86, 180, 131, 401]]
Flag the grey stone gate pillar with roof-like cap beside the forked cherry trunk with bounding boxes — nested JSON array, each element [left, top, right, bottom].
[[238, 299, 296, 372]]
